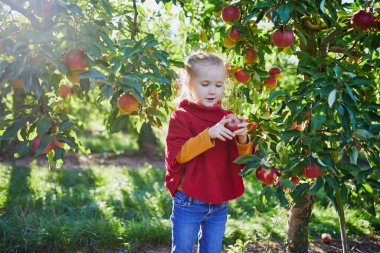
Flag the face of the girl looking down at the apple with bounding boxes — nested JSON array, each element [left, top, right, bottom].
[[190, 65, 226, 107]]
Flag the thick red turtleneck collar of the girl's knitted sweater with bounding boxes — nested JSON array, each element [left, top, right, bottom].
[[179, 99, 224, 122]]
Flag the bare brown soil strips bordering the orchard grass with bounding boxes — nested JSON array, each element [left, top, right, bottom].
[[3, 154, 380, 253]]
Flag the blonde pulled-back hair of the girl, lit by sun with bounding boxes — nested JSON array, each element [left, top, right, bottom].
[[174, 51, 224, 105]]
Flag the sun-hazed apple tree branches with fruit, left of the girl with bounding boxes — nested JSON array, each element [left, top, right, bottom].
[[0, 0, 175, 166]]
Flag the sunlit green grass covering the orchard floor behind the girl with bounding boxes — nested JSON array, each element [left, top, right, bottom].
[[0, 161, 380, 252]]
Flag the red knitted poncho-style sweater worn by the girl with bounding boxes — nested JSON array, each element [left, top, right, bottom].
[[165, 100, 248, 204]]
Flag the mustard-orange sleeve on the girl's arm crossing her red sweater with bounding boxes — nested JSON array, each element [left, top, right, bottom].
[[175, 128, 215, 163]]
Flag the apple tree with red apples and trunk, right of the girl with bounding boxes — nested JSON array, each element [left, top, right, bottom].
[[174, 0, 380, 252]]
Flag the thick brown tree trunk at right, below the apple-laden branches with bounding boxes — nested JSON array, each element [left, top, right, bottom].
[[285, 194, 315, 253]]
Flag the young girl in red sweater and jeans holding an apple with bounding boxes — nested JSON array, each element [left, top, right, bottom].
[[165, 52, 252, 253]]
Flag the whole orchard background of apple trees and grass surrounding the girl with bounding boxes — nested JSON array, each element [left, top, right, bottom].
[[0, 0, 380, 252]]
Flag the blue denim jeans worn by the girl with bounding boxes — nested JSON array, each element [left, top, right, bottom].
[[171, 191, 228, 253]]
